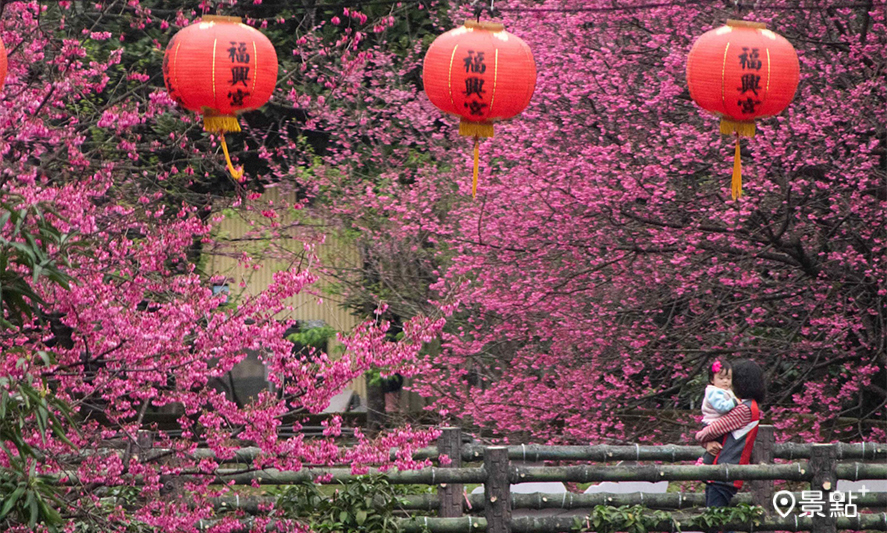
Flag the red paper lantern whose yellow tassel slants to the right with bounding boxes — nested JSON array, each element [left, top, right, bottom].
[[163, 16, 277, 179]]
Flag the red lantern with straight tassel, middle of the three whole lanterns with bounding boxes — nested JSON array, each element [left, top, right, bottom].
[[422, 20, 536, 196]]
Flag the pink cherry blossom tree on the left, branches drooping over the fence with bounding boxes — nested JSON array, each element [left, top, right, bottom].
[[0, 1, 443, 531]]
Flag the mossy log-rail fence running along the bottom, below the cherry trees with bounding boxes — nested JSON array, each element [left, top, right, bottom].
[[186, 426, 887, 533]]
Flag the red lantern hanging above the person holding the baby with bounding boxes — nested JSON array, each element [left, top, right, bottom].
[[687, 20, 800, 200]]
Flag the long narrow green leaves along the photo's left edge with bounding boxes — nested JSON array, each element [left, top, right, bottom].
[[0, 193, 79, 532]]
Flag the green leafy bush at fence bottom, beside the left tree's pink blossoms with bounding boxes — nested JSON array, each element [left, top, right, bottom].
[[277, 474, 430, 533]]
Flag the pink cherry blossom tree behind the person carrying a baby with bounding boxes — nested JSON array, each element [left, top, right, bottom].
[[306, 0, 887, 442]]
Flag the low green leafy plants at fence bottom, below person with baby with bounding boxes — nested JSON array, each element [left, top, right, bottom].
[[573, 503, 764, 533]]
